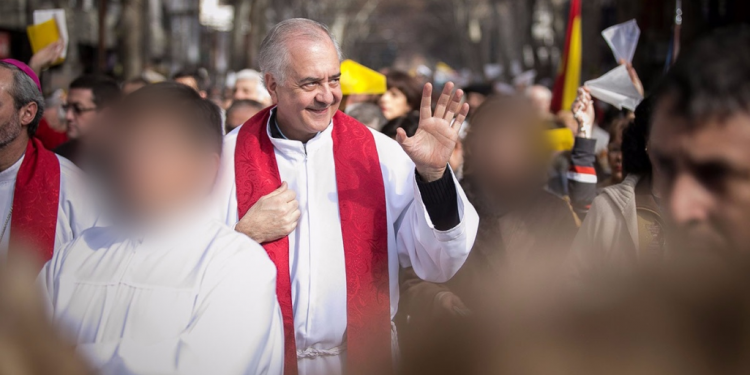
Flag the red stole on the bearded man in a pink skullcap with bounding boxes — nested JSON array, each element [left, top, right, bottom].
[[9, 138, 60, 262]]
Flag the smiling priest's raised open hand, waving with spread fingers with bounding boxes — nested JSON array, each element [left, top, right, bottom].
[[396, 82, 469, 182]]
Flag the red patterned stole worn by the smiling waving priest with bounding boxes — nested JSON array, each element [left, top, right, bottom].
[[234, 108, 393, 375]]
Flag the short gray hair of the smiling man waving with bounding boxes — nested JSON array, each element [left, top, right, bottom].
[[258, 18, 343, 82]]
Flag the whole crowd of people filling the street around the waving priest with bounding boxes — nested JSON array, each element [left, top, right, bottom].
[[0, 19, 750, 375]]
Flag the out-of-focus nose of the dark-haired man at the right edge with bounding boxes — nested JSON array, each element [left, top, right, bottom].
[[669, 174, 712, 224]]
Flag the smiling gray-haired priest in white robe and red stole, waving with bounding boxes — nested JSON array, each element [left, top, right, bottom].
[[218, 18, 478, 374]]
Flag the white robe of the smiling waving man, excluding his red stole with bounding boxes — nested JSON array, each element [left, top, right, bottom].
[[217, 112, 479, 375]]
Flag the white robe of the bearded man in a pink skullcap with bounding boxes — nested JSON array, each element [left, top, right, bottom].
[[0, 155, 98, 262]]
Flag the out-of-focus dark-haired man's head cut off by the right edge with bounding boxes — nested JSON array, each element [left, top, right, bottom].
[[652, 27, 750, 256]]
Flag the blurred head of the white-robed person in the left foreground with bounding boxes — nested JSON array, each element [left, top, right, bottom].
[[107, 82, 222, 219]]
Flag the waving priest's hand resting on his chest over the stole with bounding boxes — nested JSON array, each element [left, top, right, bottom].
[[235, 182, 300, 244]]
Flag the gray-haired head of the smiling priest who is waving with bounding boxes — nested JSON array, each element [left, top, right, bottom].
[[258, 18, 342, 142]]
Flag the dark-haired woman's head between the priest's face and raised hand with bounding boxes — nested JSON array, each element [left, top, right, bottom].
[[378, 71, 422, 121]]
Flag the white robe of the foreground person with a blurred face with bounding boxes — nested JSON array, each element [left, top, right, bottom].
[[39, 215, 284, 375]]
